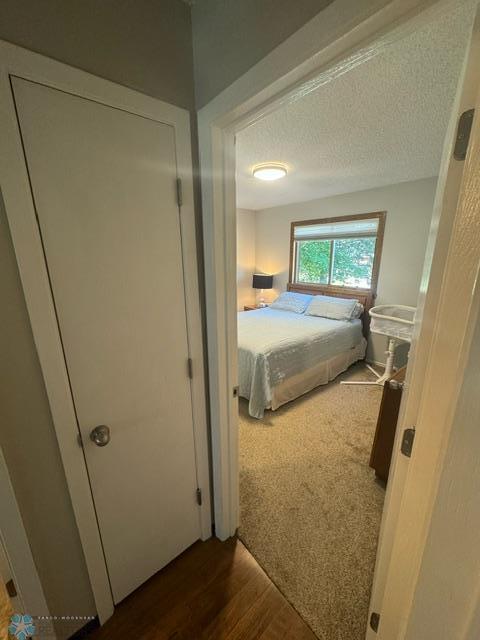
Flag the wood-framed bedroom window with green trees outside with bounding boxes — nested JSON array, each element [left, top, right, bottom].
[[290, 212, 385, 291]]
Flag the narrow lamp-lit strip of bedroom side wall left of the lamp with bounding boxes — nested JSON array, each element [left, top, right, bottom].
[[237, 209, 256, 311]]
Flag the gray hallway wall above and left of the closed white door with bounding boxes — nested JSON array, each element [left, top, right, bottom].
[[0, 0, 195, 635]]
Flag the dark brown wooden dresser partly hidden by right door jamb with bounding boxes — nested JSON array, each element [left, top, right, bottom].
[[370, 367, 407, 482]]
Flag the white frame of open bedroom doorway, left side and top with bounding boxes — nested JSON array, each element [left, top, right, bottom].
[[198, 0, 476, 632]]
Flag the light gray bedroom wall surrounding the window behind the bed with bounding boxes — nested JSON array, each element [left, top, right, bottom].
[[255, 178, 437, 364]]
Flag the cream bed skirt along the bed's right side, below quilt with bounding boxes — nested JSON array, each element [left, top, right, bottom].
[[267, 338, 367, 411]]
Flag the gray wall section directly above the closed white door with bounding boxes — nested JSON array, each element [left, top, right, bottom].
[[0, 0, 194, 109]]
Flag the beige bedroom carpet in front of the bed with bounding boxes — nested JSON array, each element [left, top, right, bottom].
[[239, 364, 385, 640]]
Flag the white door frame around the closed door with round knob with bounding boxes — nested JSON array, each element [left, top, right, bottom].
[[0, 40, 211, 623]]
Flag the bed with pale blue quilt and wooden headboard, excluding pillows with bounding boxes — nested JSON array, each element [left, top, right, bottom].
[[238, 284, 372, 418]]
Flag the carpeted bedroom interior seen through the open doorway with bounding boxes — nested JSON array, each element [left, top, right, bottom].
[[232, 4, 471, 640]]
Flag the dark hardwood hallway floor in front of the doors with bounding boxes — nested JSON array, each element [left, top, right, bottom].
[[88, 538, 316, 640]]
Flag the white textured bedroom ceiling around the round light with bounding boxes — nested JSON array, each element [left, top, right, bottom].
[[236, 2, 473, 210]]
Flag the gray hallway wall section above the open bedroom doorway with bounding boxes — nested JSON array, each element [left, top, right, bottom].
[[192, 0, 333, 108]]
